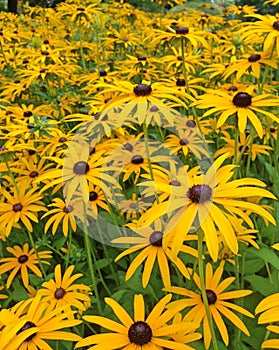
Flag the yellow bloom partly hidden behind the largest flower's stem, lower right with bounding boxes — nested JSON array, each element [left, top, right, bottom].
[[167, 263, 254, 349]]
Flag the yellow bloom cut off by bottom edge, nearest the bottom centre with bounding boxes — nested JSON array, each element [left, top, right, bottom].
[[76, 294, 199, 350]]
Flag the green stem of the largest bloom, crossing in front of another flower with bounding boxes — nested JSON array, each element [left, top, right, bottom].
[[198, 229, 218, 350]]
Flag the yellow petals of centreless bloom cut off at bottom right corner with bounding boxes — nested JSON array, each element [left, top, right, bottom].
[[255, 293, 279, 349]]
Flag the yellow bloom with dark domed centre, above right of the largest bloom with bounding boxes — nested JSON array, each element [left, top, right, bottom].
[[194, 89, 279, 138]]
